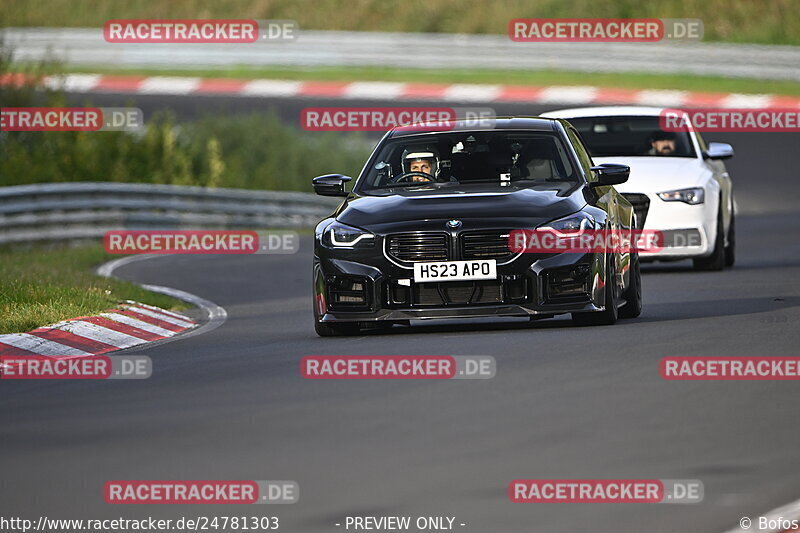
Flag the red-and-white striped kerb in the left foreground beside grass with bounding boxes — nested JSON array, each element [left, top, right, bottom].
[[0, 301, 197, 357]]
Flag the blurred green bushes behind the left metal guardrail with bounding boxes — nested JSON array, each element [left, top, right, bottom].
[[0, 42, 370, 191]]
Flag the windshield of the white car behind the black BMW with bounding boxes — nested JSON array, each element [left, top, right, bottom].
[[568, 116, 695, 157]]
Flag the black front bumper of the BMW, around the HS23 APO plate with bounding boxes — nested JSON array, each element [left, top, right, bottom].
[[314, 241, 606, 322]]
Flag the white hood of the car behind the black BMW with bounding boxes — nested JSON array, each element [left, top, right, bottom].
[[592, 156, 711, 193]]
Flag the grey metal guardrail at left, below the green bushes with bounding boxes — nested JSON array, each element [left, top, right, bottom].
[[0, 182, 339, 244]]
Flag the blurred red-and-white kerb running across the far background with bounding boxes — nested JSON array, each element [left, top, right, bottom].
[[0, 74, 800, 108]]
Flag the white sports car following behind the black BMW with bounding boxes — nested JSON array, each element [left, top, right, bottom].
[[542, 107, 736, 270]]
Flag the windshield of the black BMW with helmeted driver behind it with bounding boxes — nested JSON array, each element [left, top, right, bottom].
[[356, 131, 580, 194]]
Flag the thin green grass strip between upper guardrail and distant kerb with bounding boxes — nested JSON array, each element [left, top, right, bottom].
[[45, 67, 800, 96]]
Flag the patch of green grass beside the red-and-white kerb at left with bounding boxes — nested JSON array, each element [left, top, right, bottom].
[[0, 244, 186, 334]]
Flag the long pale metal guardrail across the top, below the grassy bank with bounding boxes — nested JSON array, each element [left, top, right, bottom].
[[0, 28, 800, 83]]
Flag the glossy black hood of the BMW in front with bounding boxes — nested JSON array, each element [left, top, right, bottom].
[[336, 188, 586, 229]]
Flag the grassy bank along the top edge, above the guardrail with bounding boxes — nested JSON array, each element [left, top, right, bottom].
[[0, 0, 800, 45]]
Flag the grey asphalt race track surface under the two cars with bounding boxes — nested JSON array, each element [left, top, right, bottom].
[[0, 95, 800, 533]]
